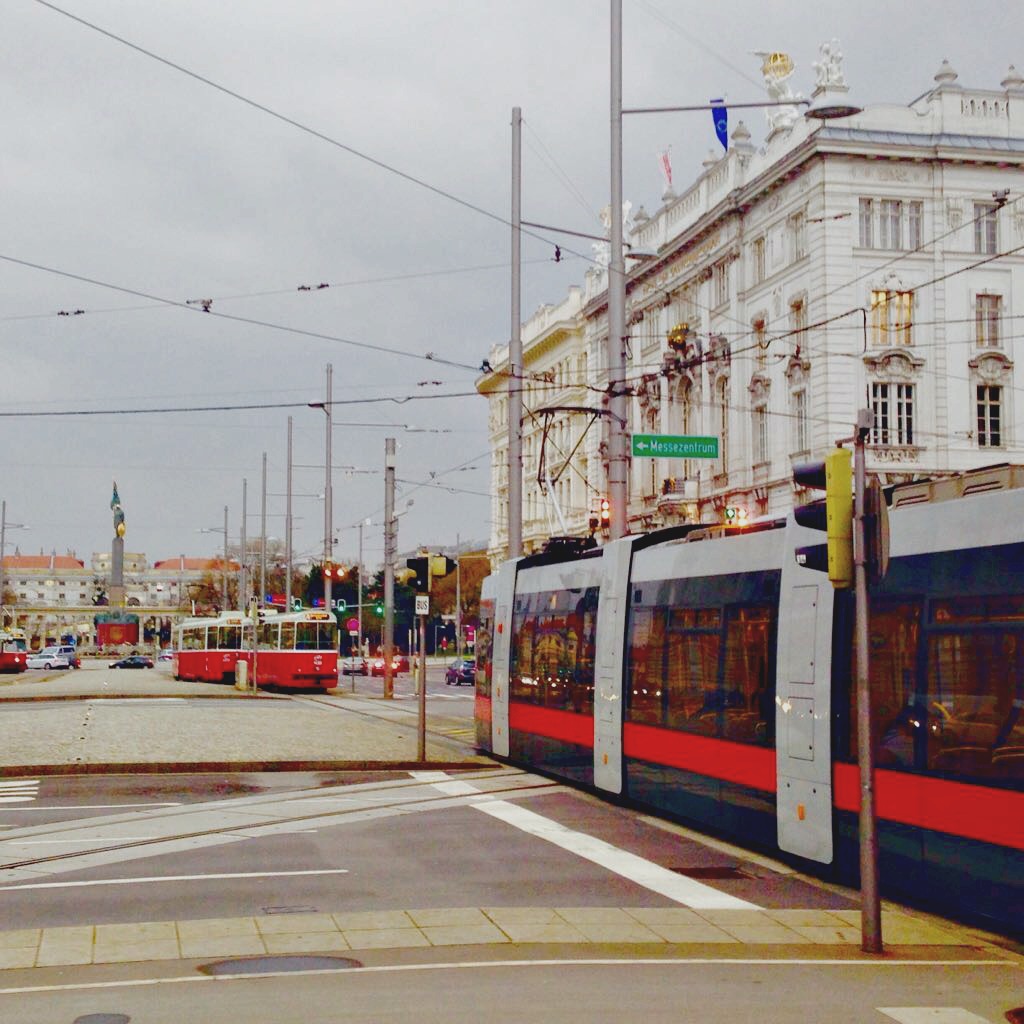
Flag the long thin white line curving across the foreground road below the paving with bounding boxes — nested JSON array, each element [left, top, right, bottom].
[[0, 956, 1007, 999]]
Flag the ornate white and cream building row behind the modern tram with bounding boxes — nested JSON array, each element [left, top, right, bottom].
[[477, 61, 1024, 557]]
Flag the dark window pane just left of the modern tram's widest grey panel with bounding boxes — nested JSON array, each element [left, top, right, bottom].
[[722, 605, 775, 745]]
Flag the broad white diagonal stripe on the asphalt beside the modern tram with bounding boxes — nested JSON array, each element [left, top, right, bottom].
[[410, 771, 761, 910]]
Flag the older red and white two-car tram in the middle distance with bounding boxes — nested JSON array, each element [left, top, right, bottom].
[[173, 609, 338, 689]]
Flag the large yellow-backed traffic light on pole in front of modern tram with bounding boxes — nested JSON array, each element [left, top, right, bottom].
[[793, 449, 853, 589]]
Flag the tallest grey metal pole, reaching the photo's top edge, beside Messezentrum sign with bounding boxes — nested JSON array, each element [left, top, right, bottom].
[[607, 0, 629, 541]]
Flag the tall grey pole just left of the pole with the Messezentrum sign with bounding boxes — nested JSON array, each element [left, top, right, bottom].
[[508, 106, 522, 558]]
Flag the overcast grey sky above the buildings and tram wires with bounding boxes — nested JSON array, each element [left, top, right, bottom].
[[0, 0, 1024, 564]]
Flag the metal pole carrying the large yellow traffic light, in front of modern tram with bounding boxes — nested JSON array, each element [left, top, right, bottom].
[[853, 410, 882, 953]]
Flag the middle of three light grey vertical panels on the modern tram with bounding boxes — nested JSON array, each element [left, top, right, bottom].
[[594, 538, 633, 793]]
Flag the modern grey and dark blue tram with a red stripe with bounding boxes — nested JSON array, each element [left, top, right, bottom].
[[475, 466, 1024, 932]]
